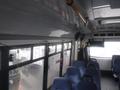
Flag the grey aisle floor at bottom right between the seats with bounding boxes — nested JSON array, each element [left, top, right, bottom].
[[101, 76, 119, 90]]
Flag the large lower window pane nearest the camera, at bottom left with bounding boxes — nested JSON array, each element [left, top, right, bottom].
[[9, 60, 44, 90]]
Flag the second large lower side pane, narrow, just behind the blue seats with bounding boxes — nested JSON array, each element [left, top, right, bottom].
[[47, 54, 61, 88]]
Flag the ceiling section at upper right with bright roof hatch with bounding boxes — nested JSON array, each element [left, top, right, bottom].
[[89, 0, 120, 32]]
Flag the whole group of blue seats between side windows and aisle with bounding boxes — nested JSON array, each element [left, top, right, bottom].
[[51, 60, 101, 90]]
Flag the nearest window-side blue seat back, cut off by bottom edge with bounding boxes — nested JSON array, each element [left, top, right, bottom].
[[51, 77, 72, 90]]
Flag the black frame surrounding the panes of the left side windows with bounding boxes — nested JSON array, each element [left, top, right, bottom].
[[0, 42, 72, 90]]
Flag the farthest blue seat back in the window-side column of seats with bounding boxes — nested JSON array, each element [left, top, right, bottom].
[[72, 61, 86, 77]]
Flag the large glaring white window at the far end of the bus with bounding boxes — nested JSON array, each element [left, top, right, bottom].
[[90, 42, 120, 58]]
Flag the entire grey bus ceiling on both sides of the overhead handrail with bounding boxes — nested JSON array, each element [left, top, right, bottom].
[[0, 0, 120, 39]]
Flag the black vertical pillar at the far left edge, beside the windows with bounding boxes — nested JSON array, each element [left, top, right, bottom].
[[0, 46, 9, 90]]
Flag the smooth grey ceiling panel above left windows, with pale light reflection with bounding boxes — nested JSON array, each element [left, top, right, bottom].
[[0, 0, 75, 38]]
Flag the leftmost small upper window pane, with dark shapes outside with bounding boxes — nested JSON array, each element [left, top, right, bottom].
[[9, 48, 31, 65]]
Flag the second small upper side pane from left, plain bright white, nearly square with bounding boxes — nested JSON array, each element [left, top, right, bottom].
[[33, 46, 45, 59]]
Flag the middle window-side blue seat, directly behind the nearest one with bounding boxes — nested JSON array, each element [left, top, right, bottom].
[[64, 66, 81, 90]]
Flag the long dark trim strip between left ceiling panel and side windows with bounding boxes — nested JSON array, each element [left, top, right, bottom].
[[0, 34, 73, 40]]
